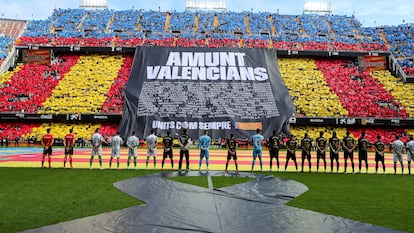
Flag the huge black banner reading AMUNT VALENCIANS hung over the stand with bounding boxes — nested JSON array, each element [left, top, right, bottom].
[[119, 47, 294, 138]]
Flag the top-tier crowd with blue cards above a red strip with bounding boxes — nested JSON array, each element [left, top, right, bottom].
[[13, 9, 387, 51]]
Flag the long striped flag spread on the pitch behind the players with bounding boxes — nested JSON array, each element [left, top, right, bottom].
[[0, 147, 408, 174]]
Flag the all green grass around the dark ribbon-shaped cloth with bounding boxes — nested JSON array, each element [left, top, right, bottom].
[[0, 168, 414, 232]]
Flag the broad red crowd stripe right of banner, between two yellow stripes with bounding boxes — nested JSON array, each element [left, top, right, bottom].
[[316, 60, 408, 118]]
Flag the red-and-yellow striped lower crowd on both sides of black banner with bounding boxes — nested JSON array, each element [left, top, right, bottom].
[[0, 54, 414, 144]]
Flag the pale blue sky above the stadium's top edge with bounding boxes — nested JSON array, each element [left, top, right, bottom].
[[0, 0, 414, 27]]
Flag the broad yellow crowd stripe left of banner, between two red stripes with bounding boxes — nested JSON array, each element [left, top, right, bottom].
[[39, 55, 123, 114]]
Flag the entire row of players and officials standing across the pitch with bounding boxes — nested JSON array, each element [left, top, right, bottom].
[[41, 128, 414, 174]]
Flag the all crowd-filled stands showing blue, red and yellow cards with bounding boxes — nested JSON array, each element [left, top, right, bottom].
[[0, 9, 414, 146]]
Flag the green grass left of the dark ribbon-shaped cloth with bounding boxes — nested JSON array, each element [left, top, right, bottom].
[[0, 168, 157, 232]]
